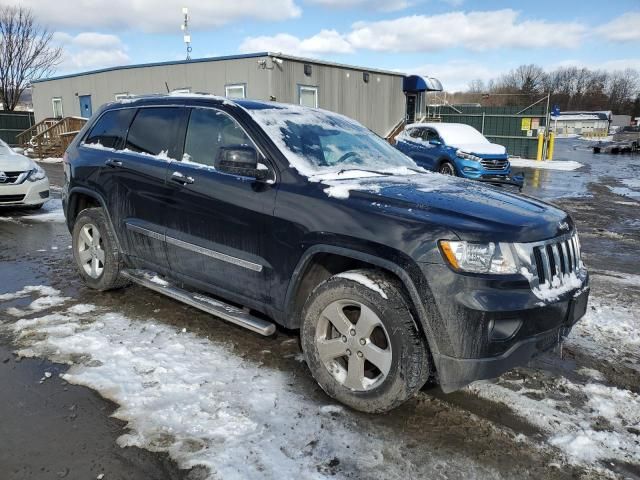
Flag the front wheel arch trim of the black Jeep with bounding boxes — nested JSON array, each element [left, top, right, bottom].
[[285, 244, 440, 357]]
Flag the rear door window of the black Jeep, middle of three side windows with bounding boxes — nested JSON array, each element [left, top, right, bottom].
[[126, 107, 186, 158]]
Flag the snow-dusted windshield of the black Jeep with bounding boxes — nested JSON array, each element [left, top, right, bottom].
[[243, 103, 419, 177]]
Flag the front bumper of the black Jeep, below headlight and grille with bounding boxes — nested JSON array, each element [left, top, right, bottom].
[[423, 264, 589, 392]]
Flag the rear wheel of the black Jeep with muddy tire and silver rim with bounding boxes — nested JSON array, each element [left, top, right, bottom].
[[72, 208, 128, 291]]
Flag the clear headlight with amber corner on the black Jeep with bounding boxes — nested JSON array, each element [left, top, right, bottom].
[[440, 240, 518, 274]]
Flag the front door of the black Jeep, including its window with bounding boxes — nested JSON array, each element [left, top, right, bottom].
[[166, 108, 275, 303]]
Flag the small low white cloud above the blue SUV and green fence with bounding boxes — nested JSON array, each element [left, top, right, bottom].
[[404, 60, 509, 92]]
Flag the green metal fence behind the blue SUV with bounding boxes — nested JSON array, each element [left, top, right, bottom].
[[430, 105, 547, 158]]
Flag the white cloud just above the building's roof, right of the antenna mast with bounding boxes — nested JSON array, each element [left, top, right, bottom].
[[239, 30, 353, 57]]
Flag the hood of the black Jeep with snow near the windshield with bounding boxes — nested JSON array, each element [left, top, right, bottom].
[[323, 173, 573, 243]]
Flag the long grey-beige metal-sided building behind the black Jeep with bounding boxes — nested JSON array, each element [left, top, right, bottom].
[[33, 52, 436, 137]]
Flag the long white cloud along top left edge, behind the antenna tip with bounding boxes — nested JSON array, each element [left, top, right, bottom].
[[14, 0, 302, 32]]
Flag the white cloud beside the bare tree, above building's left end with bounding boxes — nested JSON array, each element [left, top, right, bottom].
[[53, 32, 131, 73]]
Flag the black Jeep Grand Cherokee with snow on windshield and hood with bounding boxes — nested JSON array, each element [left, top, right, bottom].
[[63, 95, 589, 412]]
